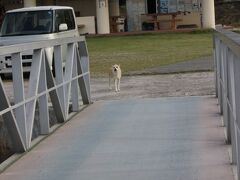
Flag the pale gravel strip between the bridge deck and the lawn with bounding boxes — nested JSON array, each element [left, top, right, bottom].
[[91, 72, 215, 101]]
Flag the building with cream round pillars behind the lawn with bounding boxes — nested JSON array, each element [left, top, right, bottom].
[[3, 0, 215, 34]]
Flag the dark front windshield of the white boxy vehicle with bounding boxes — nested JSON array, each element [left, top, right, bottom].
[[1, 10, 53, 36]]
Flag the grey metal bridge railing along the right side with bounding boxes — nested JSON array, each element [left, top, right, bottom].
[[213, 28, 240, 179]]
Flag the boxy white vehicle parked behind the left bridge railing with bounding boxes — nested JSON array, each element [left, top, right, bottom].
[[0, 6, 79, 74]]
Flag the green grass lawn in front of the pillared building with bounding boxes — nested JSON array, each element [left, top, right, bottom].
[[87, 31, 212, 76]]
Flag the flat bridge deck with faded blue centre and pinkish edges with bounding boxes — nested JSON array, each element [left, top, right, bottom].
[[0, 97, 233, 180]]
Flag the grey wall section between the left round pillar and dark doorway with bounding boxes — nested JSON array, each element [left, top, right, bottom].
[[126, 0, 146, 31]]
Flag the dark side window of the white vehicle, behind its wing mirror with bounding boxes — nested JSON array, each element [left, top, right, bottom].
[[55, 9, 75, 32]]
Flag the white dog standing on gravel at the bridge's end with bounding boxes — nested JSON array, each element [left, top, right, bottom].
[[109, 64, 122, 92]]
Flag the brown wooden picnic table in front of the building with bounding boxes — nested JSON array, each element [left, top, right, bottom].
[[142, 12, 182, 30]]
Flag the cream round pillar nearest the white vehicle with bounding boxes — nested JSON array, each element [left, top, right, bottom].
[[96, 0, 110, 34]]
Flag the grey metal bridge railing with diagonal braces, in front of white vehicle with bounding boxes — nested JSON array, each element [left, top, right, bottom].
[[0, 37, 91, 152]]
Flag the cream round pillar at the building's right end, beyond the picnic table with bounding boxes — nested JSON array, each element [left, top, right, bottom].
[[202, 0, 215, 29]]
